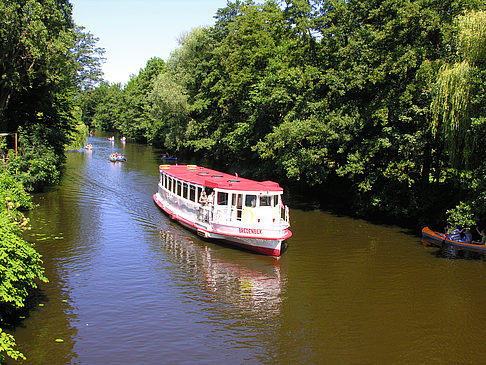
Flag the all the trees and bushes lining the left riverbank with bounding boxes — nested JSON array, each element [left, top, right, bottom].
[[0, 0, 103, 361]]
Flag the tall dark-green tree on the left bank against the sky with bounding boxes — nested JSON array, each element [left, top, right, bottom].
[[0, 0, 103, 189]]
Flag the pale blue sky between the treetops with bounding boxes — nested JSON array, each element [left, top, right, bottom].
[[70, 0, 234, 84]]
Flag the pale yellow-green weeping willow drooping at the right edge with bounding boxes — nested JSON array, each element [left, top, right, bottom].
[[432, 11, 486, 168]]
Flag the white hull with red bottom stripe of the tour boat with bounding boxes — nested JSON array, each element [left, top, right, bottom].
[[153, 193, 292, 257]]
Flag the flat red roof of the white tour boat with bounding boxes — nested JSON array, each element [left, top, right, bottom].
[[159, 165, 283, 192]]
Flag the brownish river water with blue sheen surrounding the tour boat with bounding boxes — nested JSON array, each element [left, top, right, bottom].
[[6, 138, 486, 365]]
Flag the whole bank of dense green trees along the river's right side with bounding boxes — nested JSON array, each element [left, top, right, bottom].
[[80, 0, 486, 228]]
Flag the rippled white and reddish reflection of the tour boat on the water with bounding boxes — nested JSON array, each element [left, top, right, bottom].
[[160, 229, 285, 317]]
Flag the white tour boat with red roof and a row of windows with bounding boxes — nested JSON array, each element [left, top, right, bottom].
[[153, 165, 292, 257]]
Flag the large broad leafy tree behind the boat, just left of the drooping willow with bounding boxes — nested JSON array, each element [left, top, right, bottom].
[[258, 0, 479, 222]]
